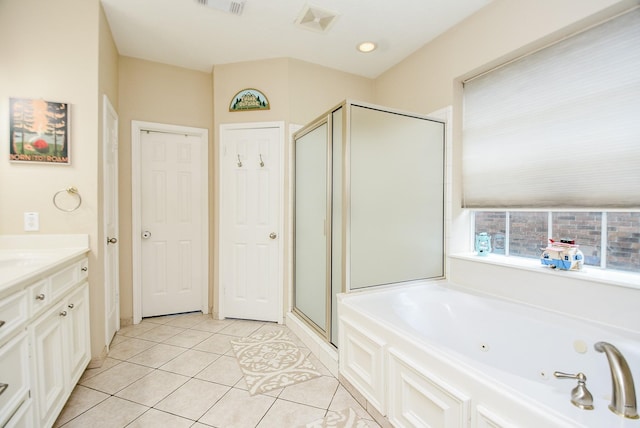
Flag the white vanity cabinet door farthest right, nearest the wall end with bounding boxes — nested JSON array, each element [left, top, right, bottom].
[[63, 283, 91, 390]]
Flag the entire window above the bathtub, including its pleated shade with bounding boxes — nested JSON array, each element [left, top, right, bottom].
[[462, 7, 640, 273]]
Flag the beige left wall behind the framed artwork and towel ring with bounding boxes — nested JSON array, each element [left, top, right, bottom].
[[0, 0, 110, 356]]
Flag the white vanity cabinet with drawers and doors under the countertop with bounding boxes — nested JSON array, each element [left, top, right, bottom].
[[0, 244, 91, 428]]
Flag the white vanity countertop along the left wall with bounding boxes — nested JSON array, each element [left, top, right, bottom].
[[0, 235, 89, 298]]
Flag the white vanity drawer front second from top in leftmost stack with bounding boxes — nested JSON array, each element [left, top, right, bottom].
[[0, 331, 29, 426]]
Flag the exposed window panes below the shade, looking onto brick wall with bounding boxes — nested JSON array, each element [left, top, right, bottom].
[[474, 211, 640, 272]]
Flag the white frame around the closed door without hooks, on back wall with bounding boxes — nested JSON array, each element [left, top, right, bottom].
[[131, 120, 209, 324]]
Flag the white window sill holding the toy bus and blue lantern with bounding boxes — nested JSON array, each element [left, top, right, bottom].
[[449, 253, 640, 289]]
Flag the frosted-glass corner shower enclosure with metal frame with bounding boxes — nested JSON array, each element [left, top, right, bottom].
[[293, 101, 445, 346]]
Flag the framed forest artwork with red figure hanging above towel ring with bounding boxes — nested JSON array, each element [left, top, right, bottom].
[[9, 98, 70, 165]]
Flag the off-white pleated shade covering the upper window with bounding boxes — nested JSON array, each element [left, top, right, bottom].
[[463, 9, 640, 209]]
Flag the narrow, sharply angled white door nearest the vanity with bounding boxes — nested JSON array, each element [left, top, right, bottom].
[[102, 95, 120, 350]]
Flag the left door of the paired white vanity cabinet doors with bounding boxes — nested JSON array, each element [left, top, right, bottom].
[[29, 304, 68, 427]]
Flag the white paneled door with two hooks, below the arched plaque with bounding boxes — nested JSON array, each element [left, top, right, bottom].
[[220, 123, 284, 322]]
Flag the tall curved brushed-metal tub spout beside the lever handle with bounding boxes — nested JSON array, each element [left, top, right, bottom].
[[593, 342, 638, 419]]
